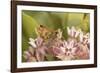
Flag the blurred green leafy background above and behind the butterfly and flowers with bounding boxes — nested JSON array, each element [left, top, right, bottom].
[[22, 10, 90, 62]]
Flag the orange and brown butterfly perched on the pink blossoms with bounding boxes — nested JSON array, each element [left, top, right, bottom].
[[35, 25, 53, 40]]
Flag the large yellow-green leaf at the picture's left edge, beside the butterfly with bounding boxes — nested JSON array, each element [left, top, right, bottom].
[[22, 12, 38, 39]]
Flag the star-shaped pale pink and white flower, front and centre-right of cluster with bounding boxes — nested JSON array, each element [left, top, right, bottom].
[[56, 39, 76, 60]]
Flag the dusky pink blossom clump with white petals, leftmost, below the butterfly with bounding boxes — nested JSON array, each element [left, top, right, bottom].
[[24, 37, 46, 61]]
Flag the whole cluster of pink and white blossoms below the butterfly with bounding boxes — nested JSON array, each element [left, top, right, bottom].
[[23, 27, 90, 62]]
